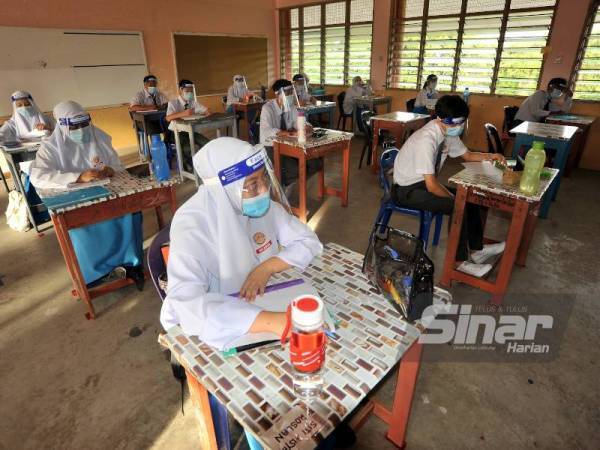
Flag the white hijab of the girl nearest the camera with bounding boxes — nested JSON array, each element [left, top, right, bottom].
[[185, 137, 259, 293]]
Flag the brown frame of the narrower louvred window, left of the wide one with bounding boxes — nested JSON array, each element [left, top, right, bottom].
[[279, 0, 376, 86]]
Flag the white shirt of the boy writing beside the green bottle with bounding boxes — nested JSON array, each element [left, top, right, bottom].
[[394, 120, 467, 186]]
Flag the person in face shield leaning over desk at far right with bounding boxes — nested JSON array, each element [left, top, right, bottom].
[[513, 78, 573, 126]]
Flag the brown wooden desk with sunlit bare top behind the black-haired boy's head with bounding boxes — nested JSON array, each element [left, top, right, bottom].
[[371, 111, 431, 173]]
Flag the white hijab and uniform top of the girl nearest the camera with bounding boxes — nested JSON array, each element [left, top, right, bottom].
[[160, 137, 322, 349]]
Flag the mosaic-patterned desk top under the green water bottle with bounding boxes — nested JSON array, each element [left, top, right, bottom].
[[448, 167, 558, 203]]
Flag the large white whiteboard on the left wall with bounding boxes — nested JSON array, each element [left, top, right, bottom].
[[0, 27, 147, 116]]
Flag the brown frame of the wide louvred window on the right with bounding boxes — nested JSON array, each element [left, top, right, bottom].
[[385, 0, 560, 97]]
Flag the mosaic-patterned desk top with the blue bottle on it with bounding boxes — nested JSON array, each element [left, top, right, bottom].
[[37, 171, 180, 214]]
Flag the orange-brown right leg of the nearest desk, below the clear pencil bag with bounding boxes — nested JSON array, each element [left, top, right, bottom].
[[386, 341, 423, 448]]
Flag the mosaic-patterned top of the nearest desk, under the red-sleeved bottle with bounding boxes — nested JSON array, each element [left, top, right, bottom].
[[159, 244, 451, 450]]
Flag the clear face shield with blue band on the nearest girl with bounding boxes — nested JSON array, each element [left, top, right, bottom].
[[219, 145, 292, 218]]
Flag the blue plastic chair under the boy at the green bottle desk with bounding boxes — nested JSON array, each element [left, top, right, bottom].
[[375, 148, 444, 249]]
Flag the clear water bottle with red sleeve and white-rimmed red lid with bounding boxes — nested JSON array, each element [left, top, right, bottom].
[[290, 295, 325, 402]]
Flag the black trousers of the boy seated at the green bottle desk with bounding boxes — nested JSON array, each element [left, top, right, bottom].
[[392, 181, 485, 261]]
